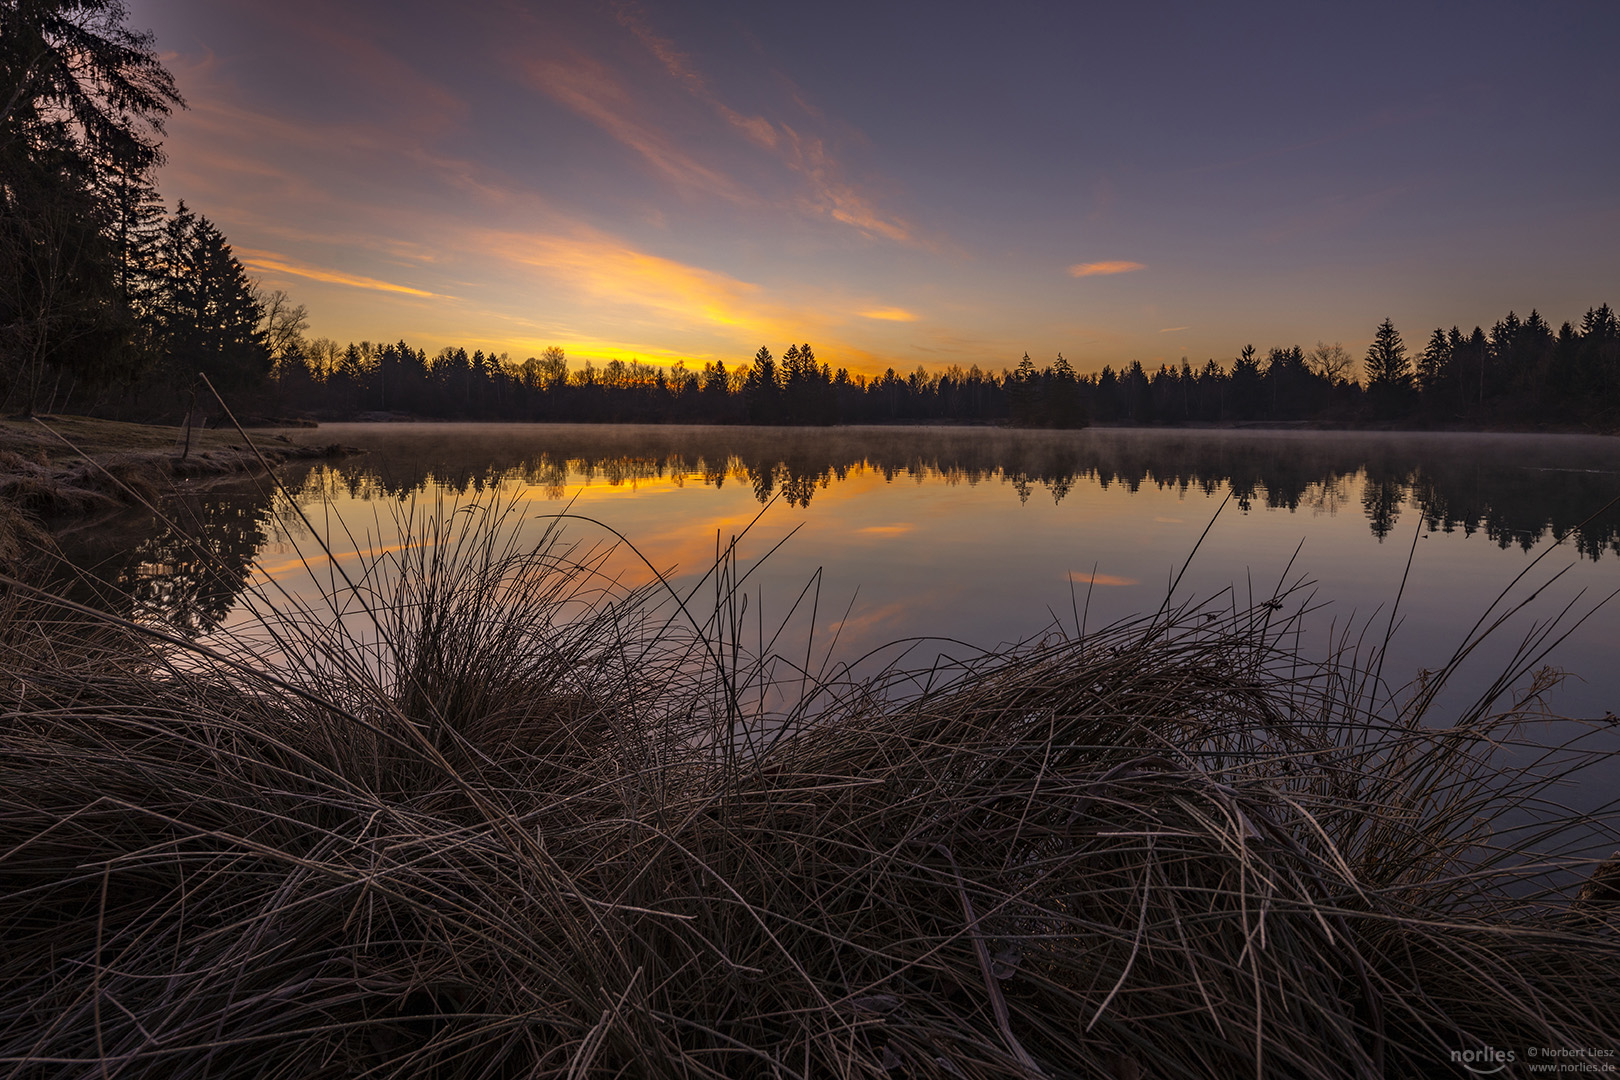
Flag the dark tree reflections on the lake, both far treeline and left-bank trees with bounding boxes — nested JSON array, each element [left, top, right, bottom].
[[44, 424, 1620, 633]]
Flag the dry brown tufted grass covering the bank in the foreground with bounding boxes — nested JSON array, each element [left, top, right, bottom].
[[0, 508, 1620, 1080]]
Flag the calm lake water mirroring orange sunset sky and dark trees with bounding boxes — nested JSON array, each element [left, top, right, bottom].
[[63, 424, 1620, 744]]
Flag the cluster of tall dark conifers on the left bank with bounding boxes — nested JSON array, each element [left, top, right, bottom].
[[0, 0, 278, 418]]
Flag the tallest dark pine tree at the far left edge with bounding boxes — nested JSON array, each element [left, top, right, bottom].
[[0, 0, 181, 408]]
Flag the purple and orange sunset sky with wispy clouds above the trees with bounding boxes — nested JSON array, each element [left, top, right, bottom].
[[119, 0, 1620, 374]]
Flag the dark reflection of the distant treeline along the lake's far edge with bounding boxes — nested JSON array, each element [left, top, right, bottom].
[[278, 426, 1620, 559]]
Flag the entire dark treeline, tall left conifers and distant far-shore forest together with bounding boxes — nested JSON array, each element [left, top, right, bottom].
[[0, 10, 1620, 429]]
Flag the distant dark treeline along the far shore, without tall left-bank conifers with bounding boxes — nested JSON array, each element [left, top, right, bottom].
[[243, 304, 1620, 427]]
